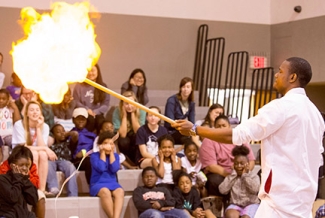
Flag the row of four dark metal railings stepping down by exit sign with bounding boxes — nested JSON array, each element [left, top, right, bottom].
[[193, 24, 278, 120]]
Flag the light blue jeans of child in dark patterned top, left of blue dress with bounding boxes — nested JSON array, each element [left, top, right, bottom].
[[46, 160, 78, 197]]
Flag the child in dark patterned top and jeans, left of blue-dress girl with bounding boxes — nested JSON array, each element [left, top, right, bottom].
[[46, 124, 78, 197]]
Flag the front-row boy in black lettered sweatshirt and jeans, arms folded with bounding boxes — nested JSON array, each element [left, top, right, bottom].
[[133, 167, 189, 218]]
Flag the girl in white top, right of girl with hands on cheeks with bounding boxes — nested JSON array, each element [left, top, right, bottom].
[[181, 139, 207, 197]]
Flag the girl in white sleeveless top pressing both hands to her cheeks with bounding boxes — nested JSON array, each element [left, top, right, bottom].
[[152, 134, 181, 193]]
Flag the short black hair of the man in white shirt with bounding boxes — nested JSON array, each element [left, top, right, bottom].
[[286, 57, 312, 88]]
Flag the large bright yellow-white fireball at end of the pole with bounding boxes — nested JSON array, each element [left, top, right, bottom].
[[11, 2, 101, 103]]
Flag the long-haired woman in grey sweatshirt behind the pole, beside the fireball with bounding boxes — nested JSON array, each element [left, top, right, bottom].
[[73, 64, 110, 132]]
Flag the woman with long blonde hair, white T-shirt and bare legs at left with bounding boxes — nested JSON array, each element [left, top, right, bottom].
[[12, 101, 57, 192]]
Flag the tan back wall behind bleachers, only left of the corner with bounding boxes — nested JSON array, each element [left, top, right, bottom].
[[0, 7, 270, 90]]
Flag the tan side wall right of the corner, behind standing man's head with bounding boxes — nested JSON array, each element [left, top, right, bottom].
[[271, 16, 325, 83]]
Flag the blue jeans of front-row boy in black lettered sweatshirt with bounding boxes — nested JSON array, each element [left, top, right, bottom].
[[139, 209, 189, 218]]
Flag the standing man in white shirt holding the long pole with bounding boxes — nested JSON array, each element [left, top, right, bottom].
[[174, 57, 325, 218]]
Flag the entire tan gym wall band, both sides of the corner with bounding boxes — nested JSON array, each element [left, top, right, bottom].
[[0, 7, 325, 108]]
